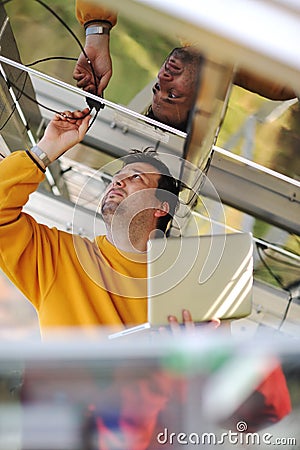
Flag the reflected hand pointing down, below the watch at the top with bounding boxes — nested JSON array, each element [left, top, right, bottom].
[[73, 35, 112, 96]]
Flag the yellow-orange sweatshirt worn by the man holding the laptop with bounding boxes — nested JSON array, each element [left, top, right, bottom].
[[0, 151, 147, 329]]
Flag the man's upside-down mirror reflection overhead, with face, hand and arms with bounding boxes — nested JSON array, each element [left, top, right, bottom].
[[73, 0, 296, 131]]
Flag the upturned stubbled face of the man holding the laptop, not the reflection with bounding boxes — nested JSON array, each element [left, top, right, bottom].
[[101, 162, 161, 221]]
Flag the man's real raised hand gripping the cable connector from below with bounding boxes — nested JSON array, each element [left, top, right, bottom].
[[38, 108, 91, 161]]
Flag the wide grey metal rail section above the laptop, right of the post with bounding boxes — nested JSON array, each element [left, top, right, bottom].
[[203, 147, 300, 235]]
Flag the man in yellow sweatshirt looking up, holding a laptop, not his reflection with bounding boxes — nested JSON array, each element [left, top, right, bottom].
[[0, 109, 178, 332]]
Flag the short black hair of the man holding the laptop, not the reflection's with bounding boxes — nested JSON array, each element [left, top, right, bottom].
[[122, 147, 180, 233]]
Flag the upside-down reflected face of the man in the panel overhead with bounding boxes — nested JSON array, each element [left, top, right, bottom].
[[152, 48, 199, 128]]
